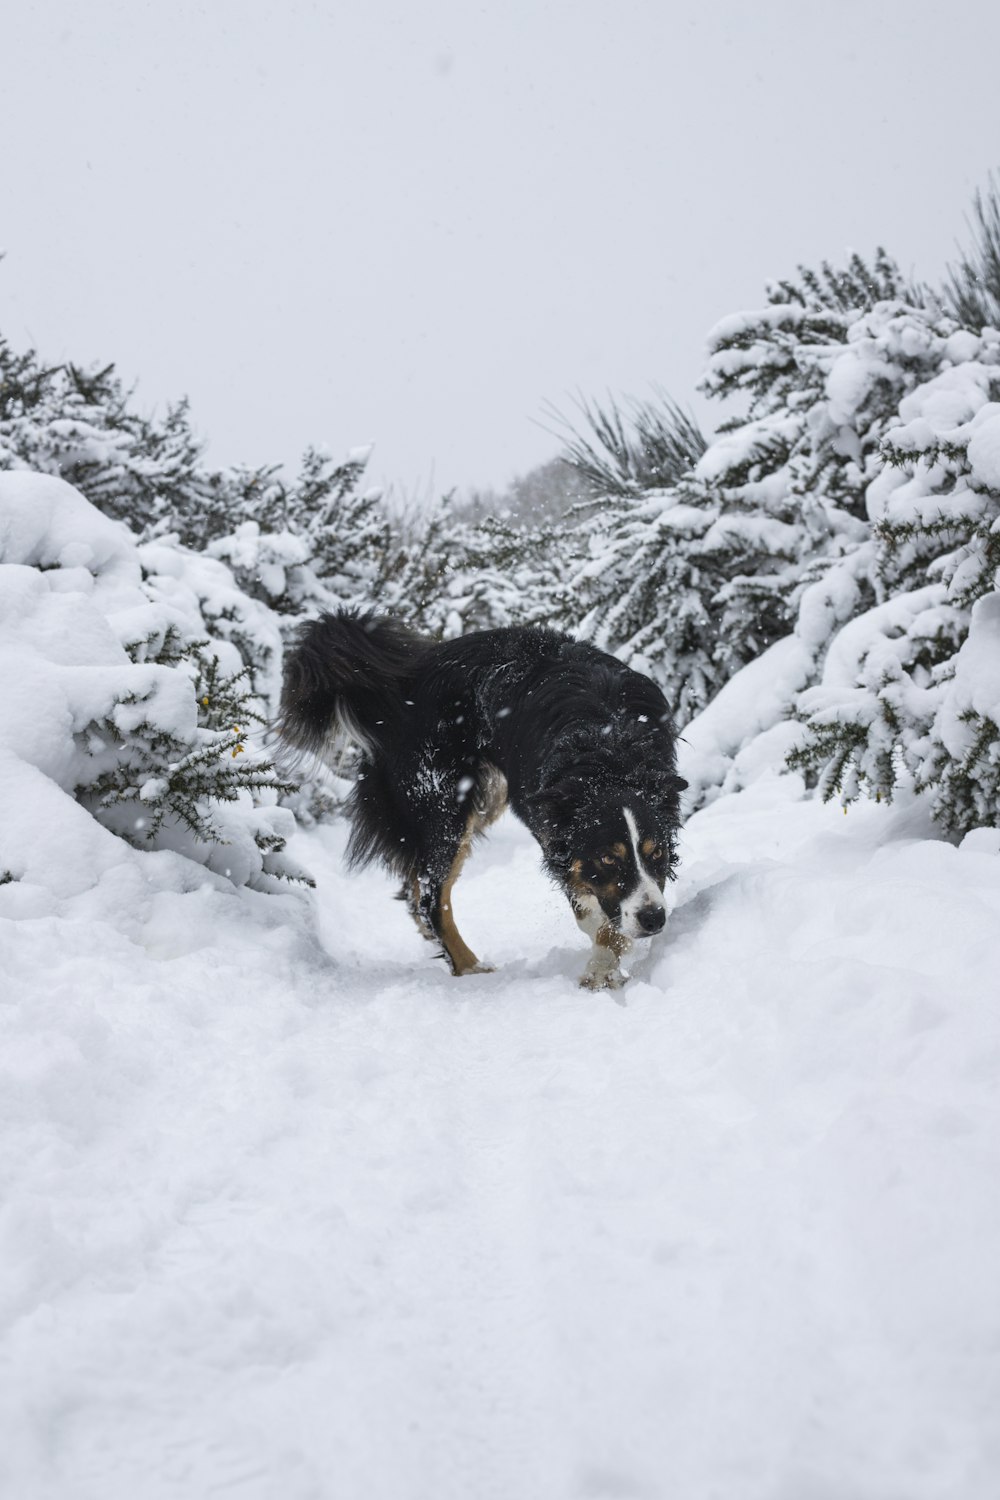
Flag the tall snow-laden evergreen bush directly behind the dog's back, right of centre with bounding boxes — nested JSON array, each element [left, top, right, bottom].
[[568, 252, 954, 722]]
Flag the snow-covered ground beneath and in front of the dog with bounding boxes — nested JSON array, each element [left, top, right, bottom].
[[0, 776, 1000, 1500]]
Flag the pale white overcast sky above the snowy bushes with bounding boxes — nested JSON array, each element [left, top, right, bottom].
[[0, 0, 1000, 494]]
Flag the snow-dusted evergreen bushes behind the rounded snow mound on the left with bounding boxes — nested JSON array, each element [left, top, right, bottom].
[[0, 339, 416, 648]]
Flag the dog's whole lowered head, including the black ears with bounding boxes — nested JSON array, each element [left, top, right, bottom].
[[539, 777, 687, 938]]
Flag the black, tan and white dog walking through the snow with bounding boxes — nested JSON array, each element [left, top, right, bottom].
[[277, 609, 687, 990]]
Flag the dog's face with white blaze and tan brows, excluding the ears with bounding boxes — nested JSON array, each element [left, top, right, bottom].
[[568, 800, 673, 938]]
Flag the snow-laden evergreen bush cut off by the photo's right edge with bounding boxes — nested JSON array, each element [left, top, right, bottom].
[[793, 337, 1000, 833]]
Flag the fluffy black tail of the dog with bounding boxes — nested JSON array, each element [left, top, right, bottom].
[[277, 609, 430, 764]]
